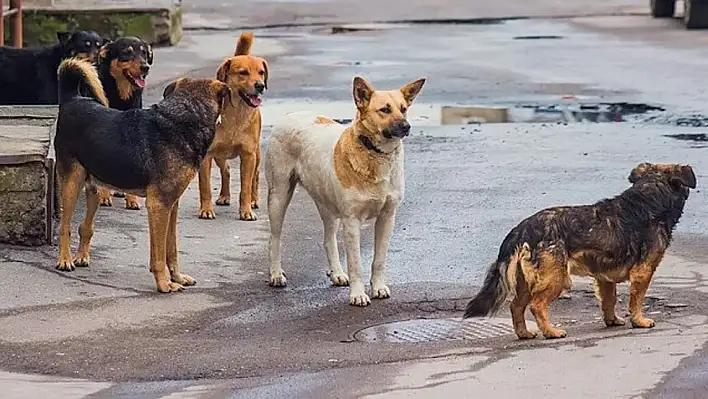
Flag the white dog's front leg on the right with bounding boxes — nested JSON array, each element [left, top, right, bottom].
[[371, 206, 396, 299]]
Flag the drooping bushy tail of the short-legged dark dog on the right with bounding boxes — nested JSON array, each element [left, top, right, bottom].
[[462, 243, 535, 319]]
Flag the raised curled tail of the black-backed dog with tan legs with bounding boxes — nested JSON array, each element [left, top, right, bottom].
[[57, 58, 108, 107]]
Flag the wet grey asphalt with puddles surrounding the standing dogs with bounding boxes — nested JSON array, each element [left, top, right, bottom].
[[0, 2, 708, 398]]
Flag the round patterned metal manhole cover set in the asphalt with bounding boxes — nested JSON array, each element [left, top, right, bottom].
[[354, 318, 536, 342]]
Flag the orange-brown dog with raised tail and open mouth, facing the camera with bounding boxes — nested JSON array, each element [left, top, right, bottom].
[[199, 32, 268, 220]]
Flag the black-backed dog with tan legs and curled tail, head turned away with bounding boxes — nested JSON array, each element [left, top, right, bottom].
[[54, 59, 231, 292]]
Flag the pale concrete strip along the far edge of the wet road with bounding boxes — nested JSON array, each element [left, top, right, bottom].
[[182, 0, 649, 30]]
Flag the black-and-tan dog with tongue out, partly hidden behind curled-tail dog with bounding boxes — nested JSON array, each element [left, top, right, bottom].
[[91, 36, 153, 210]]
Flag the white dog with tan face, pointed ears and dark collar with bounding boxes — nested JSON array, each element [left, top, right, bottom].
[[265, 77, 425, 306]]
